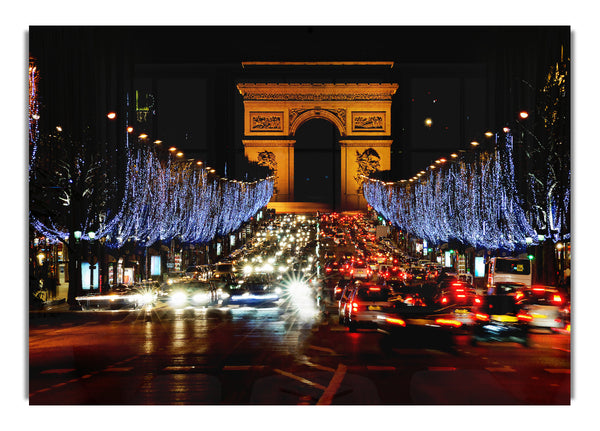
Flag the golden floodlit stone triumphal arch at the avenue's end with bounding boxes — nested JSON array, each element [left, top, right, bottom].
[[237, 83, 398, 210]]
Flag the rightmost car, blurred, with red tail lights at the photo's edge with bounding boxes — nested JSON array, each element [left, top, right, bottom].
[[515, 285, 567, 330]]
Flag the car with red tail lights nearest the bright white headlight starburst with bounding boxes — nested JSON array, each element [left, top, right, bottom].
[[346, 283, 398, 332]]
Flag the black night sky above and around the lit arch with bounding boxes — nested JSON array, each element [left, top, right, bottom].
[[29, 26, 570, 187]]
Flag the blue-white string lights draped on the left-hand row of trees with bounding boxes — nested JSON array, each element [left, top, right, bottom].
[[30, 137, 274, 248]]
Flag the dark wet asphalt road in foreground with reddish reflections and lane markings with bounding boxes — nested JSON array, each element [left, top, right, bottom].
[[26, 302, 571, 405]]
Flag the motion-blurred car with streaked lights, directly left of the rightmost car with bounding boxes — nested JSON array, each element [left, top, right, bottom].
[[471, 295, 533, 347]]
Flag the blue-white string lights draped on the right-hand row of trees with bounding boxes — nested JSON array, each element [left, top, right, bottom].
[[363, 134, 537, 251]]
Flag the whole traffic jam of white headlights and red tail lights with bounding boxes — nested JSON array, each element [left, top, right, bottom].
[[77, 212, 570, 346]]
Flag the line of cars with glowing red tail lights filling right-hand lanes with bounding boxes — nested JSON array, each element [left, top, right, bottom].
[[316, 214, 570, 346]]
